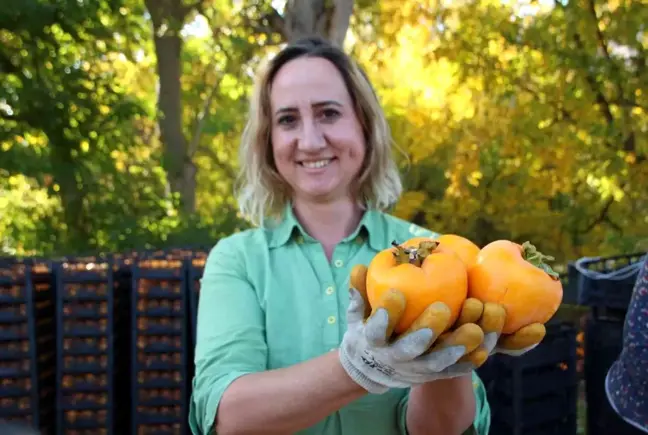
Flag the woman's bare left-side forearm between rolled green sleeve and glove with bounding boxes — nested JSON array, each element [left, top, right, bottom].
[[216, 351, 367, 435]]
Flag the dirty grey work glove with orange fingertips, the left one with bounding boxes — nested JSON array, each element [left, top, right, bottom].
[[340, 265, 484, 394]]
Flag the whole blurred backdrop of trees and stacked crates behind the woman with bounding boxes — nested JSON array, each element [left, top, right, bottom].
[[0, 0, 648, 435]]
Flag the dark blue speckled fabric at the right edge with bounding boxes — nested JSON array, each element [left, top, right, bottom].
[[605, 255, 648, 433]]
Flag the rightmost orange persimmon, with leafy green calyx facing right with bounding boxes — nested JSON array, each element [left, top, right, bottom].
[[468, 240, 563, 334]]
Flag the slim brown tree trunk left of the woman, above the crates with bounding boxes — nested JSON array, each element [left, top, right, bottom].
[[146, 0, 196, 213]]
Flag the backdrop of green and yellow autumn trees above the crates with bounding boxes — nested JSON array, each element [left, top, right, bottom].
[[0, 0, 648, 262]]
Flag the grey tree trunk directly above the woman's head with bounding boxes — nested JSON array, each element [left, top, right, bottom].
[[283, 0, 354, 47]]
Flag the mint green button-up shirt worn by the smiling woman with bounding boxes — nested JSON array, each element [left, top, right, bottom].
[[189, 207, 490, 435]]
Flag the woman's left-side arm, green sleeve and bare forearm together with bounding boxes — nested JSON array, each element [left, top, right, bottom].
[[189, 238, 366, 435]]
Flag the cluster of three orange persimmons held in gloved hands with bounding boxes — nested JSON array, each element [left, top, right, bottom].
[[366, 234, 563, 335]]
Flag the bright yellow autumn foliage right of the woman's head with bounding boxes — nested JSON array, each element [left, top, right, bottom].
[[346, 0, 648, 259]]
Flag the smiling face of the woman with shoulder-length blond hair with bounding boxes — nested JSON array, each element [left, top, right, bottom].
[[270, 57, 365, 202]]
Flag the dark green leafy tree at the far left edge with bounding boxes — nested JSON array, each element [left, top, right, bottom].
[[0, 0, 157, 252]]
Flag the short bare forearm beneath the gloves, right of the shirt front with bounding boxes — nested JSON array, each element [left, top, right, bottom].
[[406, 375, 476, 435]]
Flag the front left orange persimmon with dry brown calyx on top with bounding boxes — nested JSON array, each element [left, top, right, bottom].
[[367, 237, 468, 334]]
